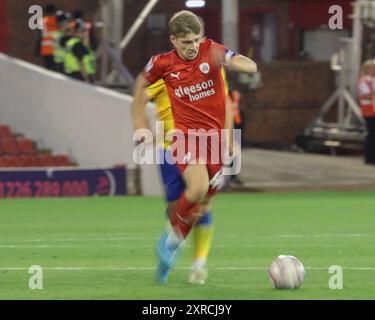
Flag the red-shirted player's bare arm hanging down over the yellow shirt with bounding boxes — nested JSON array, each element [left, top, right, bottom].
[[131, 73, 150, 131]]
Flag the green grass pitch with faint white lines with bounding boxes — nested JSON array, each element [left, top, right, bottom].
[[0, 191, 375, 300]]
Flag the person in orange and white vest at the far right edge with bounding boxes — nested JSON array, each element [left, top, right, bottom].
[[358, 60, 375, 165]]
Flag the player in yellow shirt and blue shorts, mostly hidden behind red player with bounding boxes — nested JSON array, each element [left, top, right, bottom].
[[147, 68, 229, 284]]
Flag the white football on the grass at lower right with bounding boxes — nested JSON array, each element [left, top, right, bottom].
[[268, 255, 305, 289]]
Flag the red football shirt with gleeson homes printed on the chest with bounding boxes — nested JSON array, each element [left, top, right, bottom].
[[144, 40, 234, 133]]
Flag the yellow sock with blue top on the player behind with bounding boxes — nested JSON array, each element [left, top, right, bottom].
[[192, 211, 214, 271]]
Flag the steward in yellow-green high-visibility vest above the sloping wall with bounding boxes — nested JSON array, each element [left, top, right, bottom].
[[61, 19, 96, 83]]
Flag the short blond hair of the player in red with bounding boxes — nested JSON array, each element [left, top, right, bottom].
[[169, 10, 204, 37]]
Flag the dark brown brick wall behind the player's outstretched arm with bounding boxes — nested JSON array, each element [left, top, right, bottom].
[[242, 61, 335, 145]]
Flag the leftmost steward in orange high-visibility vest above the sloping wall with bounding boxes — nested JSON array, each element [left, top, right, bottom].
[[37, 4, 59, 70]]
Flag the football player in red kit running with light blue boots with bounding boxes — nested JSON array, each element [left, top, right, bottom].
[[132, 11, 257, 283]]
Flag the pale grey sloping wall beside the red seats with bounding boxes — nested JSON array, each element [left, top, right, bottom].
[[0, 54, 161, 194]]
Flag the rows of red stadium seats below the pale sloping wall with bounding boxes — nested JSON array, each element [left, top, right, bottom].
[[0, 125, 74, 167]]
